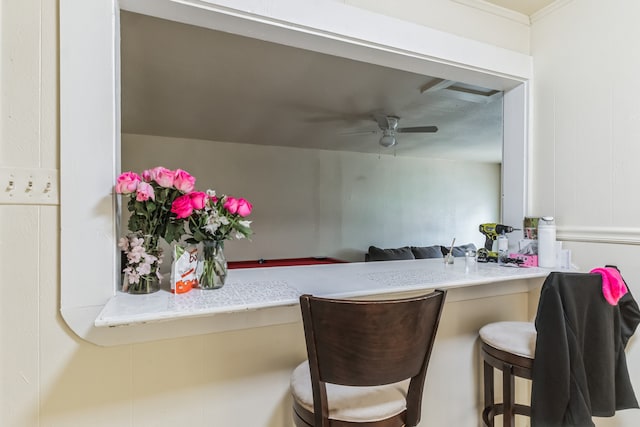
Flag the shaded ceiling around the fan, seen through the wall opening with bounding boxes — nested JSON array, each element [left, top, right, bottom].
[[121, 10, 510, 163]]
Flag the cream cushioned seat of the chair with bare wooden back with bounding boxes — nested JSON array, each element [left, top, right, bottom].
[[291, 361, 409, 422]]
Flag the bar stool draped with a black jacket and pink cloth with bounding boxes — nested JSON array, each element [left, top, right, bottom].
[[480, 266, 640, 426]]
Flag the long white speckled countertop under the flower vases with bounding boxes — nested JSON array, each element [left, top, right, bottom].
[[95, 258, 550, 327]]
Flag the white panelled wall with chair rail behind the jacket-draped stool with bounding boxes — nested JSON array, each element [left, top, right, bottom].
[[531, 0, 640, 426]]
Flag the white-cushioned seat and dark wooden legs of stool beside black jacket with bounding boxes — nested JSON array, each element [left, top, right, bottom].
[[480, 322, 536, 427]]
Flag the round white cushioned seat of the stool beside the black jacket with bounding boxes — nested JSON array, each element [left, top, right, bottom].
[[480, 322, 537, 359]]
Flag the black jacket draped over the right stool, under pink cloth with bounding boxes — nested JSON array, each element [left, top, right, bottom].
[[531, 273, 640, 427]]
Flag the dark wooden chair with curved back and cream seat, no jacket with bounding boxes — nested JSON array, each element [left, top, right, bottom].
[[291, 290, 446, 427]]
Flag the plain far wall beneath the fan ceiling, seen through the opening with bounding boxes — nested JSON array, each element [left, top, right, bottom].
[[122, 134, 500, 261]]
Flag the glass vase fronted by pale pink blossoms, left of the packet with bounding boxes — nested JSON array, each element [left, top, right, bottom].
[[121, 233, 162, 294]]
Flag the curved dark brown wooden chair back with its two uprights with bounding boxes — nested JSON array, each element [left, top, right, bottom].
[[300, 290, 446, 426]]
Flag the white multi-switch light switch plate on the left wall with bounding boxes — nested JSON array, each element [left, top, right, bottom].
[[0, 168, 60, 205]]
